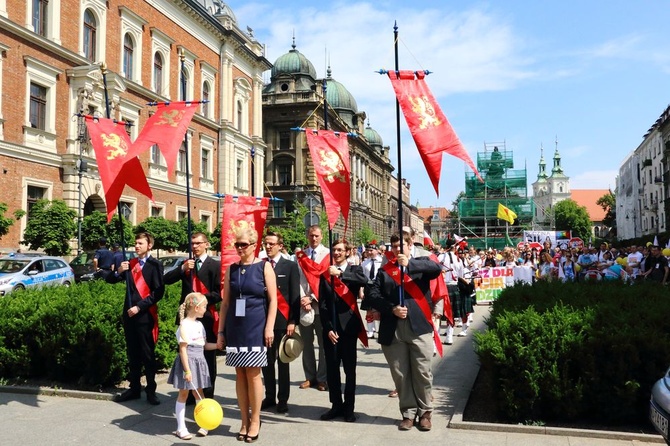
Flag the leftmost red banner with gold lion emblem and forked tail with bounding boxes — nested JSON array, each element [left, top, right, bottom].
[[86, 116, 153, 222]]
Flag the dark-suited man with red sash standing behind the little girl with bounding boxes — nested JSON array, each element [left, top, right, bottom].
[[164, 232, 221, 398]]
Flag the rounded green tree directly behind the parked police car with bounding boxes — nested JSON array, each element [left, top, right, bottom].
[[22, 200, 77, 255]]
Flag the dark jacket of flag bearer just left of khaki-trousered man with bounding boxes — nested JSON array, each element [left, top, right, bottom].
[[319, 265, 368, 336]]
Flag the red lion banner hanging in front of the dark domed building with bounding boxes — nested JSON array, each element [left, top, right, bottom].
[[305, 129, 351, 233]]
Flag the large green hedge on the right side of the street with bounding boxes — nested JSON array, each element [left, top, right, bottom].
[[476, 282, 670, 424]]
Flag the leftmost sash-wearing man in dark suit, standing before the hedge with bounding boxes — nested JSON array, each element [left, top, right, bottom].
[[107, 232, 165, 406]]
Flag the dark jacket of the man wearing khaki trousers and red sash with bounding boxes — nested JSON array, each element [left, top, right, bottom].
[[366, 257, 442, 345]]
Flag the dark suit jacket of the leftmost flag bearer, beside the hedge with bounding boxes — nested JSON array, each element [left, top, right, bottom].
[[106, 257, 165, 326]]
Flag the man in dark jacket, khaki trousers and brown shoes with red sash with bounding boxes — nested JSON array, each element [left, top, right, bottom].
[[366, 233, 442, 431]]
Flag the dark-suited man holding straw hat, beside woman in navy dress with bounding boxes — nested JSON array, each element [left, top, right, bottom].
[[261, 232, 300, 413]]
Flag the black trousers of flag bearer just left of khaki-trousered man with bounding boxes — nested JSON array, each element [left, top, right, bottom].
[[322, 330, 358, 414]]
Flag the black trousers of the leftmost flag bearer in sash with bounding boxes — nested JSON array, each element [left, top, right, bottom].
[[123, 318, 157, 394]]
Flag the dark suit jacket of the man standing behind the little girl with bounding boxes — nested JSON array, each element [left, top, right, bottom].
[[164, 256, 221, 342]]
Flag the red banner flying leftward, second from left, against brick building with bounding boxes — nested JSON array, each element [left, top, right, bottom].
[[130, 102, 198, 173]]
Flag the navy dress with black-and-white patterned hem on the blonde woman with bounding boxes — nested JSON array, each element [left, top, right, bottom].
[[225, 262, 268, 367]]
